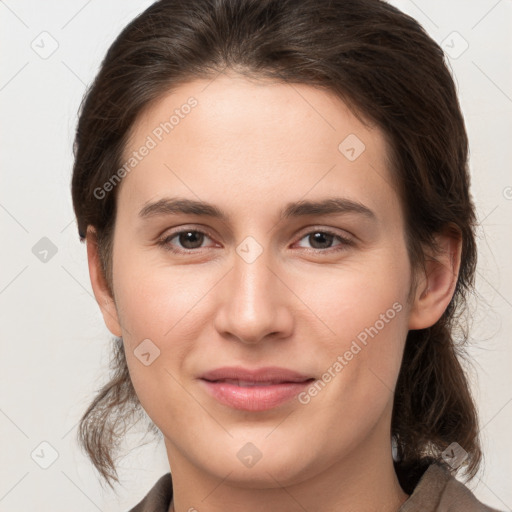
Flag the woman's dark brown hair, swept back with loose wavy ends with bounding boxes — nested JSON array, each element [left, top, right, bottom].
[[72, 0, 482, 493]]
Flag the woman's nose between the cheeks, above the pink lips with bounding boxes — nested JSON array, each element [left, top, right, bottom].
[[215, 243, 293, 345]]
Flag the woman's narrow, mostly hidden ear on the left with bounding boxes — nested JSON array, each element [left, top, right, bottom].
[[86, 226, 122, 337]]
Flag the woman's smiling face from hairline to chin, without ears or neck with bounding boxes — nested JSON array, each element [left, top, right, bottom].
[[98, 75, 420, 487]]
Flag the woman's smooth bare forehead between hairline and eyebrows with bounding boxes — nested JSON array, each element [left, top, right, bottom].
[[119, 74, 397, 226]]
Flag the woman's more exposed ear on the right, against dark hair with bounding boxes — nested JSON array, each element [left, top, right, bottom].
[[409, 228, 462, 329]]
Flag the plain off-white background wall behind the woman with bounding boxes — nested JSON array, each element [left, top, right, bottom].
[[0, 0, 512, 512]]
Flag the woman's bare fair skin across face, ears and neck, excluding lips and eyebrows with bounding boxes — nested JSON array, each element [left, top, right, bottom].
[[87, 73, 461, 512]]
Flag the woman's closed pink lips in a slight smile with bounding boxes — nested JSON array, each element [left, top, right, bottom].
[[200, 366, 314, 411]]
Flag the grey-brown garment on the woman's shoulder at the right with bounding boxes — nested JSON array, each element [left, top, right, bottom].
[[399, 463, 500, 512]]
